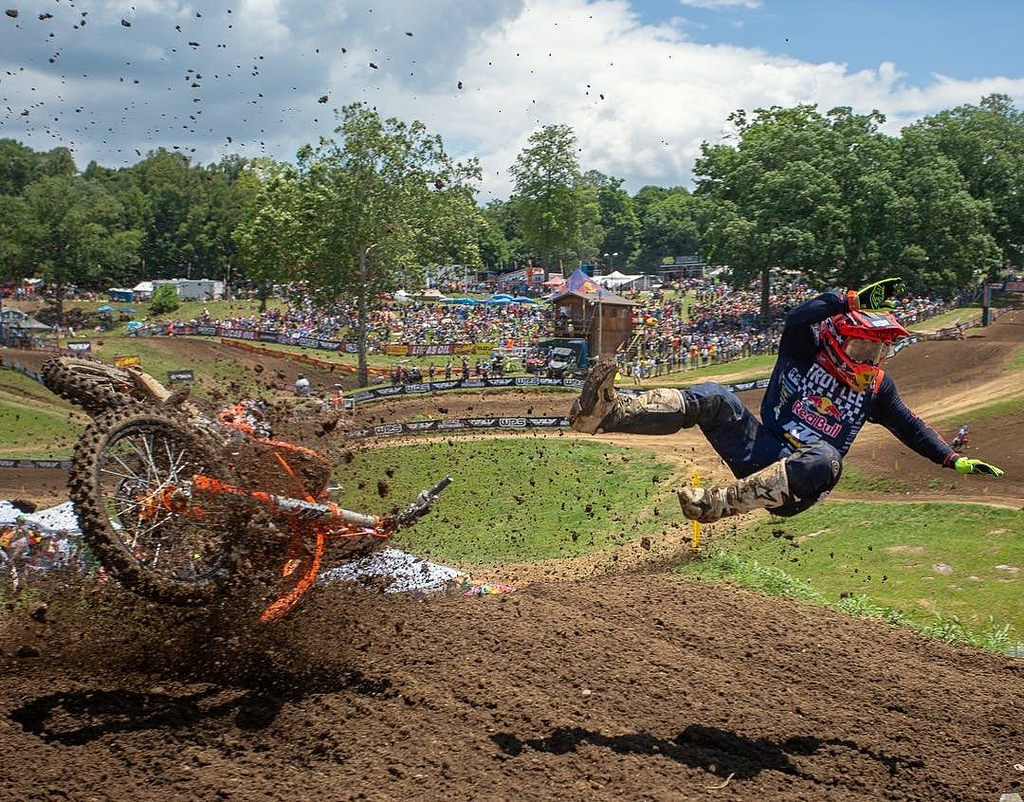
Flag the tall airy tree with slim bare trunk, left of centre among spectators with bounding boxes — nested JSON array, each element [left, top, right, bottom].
[[284, 103, 482, 384]]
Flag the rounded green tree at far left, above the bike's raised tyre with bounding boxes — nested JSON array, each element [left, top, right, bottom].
[[22, 176, 140, 325]]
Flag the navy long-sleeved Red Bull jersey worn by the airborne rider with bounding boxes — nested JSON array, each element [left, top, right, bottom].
[[761, 292, 956, 465]]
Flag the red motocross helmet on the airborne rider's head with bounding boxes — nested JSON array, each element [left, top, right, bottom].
[[817, 310, 909, 392]]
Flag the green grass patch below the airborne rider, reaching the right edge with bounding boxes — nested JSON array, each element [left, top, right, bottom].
[[682, 502, 1024, 650]]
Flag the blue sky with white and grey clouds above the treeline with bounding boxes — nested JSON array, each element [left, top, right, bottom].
[[0, 0, 1024, 202]]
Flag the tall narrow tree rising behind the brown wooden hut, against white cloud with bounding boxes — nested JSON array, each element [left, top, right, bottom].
[[512, 125, 604, 266]]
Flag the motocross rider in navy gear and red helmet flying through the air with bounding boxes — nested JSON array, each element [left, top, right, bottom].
[[569, 279, 1002, 523]]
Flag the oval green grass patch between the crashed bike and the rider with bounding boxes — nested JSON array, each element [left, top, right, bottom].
[[338, 437, 680, 565]]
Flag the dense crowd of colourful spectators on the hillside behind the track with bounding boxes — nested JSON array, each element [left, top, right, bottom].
[[149, 278, 961, 382]]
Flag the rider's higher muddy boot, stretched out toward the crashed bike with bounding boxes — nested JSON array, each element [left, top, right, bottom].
[[569, 362, 697, 434]]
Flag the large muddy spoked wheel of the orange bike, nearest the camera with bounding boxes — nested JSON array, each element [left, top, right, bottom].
[[69, 411, 245, 604]]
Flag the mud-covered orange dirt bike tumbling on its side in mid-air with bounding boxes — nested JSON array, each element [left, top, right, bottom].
[[43, 357, 451, 622]]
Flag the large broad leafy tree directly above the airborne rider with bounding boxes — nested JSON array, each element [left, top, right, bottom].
[[696, 105, 993, 313]]
